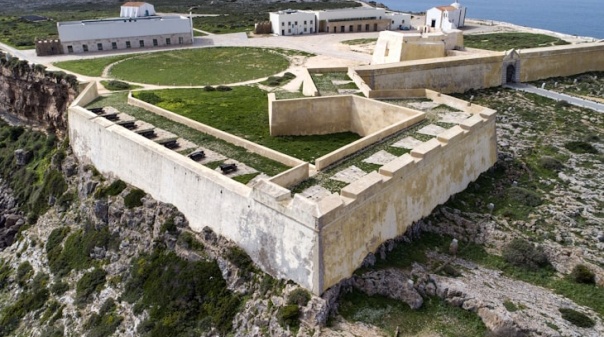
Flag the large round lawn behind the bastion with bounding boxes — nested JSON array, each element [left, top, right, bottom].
[[111, 47, 289, 85]]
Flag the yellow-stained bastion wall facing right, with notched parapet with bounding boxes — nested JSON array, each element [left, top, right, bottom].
[[319, 113, 497, 289]]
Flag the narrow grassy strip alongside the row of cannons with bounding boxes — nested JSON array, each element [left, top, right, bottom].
[[89, 93, 288, 176]]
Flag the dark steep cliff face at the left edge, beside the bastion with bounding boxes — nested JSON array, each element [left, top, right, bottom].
[[0, 53, 77, 137]]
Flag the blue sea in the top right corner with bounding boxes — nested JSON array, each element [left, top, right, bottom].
[[376, 0, 604, 39]]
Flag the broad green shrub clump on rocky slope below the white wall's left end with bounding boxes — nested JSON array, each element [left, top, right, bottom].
[[46, 224, 118, 277]]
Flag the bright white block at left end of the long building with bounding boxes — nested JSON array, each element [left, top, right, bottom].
[[270, 10, 316, 35]]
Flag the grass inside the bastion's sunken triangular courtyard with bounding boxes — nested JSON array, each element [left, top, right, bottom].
[[135, 86, 360, 162]]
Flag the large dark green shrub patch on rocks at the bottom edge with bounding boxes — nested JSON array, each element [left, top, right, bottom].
[[123, 249, 241, 336]]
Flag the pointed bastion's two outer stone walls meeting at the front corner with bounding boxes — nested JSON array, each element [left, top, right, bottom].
[[68, 84, 497, 294]]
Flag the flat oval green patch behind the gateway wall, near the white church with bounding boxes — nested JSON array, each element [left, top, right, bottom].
[[464, 33, 568, 51]]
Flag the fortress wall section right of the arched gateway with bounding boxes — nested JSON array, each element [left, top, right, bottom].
[[519, 42, 604, 82]]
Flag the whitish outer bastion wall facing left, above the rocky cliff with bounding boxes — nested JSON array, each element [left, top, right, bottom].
[[69, 107, 322, 294]]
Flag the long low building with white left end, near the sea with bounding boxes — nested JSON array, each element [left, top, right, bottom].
[[270, 7, 411, 35]]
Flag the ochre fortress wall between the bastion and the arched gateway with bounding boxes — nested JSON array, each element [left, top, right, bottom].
[[355, 53, 504, 93]]
